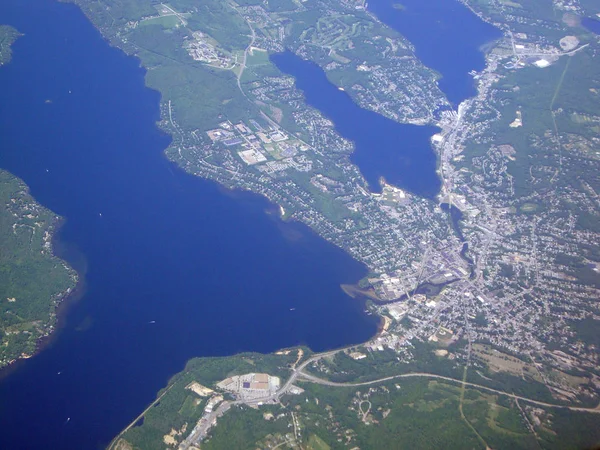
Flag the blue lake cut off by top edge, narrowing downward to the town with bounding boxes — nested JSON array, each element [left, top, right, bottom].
[[367, 0, 502, 106]]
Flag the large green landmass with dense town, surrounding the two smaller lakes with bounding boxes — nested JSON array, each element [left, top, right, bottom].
[[50, 0, 600, 450]]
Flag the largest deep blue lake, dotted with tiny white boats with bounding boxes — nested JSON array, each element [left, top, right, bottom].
[[0, 0, 377, 450]]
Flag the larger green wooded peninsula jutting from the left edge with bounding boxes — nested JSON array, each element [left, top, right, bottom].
[[0, 170, 77, 367]]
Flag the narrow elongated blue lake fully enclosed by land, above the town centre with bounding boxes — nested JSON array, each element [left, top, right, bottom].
[[271, 51, 440, 199]]
